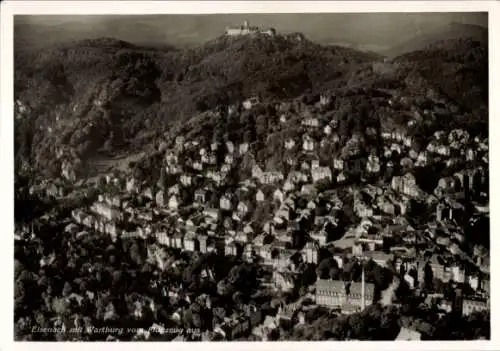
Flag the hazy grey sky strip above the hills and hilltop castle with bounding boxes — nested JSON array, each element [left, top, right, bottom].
[[14, 13, 488, 51]]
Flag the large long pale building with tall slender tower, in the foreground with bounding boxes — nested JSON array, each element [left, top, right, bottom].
[[316, 279, 375, 310]]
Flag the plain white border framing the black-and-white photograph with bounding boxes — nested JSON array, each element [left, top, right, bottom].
[[0, 1, 500, 351]]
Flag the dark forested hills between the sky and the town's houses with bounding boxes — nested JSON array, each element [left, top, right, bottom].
[[15, 34, 487, 184]]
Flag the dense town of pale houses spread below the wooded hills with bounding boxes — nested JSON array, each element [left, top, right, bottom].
[[16, 88, 490, 340]]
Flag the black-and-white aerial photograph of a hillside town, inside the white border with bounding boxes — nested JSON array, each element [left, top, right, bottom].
[[9, 12, 491, 343]]
